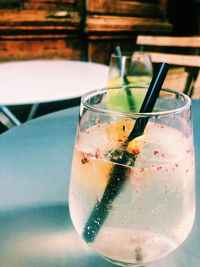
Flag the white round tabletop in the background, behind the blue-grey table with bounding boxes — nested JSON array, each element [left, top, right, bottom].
[[0, 60, 108, 105]]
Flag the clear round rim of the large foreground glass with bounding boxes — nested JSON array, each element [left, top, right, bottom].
[[81, 85, 191, 118]]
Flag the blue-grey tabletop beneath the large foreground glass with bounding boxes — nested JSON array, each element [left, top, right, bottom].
[[0, 101, 200, 267]]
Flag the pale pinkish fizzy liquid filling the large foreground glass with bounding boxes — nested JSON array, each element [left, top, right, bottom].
[[69, 122, 195, 264]]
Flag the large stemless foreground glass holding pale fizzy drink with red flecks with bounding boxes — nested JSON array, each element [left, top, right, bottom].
[[69, 86, 195, 266]]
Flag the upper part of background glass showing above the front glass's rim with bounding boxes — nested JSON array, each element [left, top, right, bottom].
[[108, 52, 153, 86]]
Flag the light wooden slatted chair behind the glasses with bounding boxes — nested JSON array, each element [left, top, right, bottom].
[[136, 35, 200, 98]]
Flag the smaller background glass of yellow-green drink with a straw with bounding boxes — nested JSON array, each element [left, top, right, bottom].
[[108, 52, 153, 112]]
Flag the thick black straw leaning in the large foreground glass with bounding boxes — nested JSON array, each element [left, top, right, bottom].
[[82, 63, 169, 243]]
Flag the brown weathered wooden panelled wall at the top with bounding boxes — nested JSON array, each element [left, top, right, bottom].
[[0, 0, 172, 63]]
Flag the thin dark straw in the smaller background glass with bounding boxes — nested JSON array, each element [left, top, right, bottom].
[[115, 46, 135, 111]]
